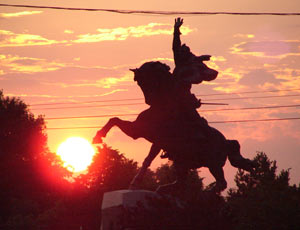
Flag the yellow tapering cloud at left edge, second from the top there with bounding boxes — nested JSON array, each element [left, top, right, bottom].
[[0, 30, 67, 47]]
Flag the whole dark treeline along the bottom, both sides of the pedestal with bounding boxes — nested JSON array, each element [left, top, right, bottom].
[[0, 91, 300, 230]]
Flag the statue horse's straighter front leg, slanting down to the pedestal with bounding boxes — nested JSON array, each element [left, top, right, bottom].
[[129, 144, 161, 189]]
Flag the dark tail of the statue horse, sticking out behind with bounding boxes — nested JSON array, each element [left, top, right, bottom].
[[226, 140, 255, 172]]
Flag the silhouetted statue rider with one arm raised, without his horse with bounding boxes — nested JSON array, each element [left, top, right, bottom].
[[165, 18, 218, 147]]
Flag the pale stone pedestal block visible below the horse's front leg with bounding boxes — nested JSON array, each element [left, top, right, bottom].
[[101, 190, 159, 230]]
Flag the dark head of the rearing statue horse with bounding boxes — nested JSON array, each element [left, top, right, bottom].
[[130, 62, 172, 105]]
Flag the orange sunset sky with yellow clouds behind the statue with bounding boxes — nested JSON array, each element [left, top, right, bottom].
[[0, 0, 300, 189]]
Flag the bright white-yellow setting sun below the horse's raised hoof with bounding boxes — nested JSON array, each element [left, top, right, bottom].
[[57, 137, 95, 172]]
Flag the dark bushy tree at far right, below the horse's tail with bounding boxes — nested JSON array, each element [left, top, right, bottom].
[[227, 153, 300, 229]]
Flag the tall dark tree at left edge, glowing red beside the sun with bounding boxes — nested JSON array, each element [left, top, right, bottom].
[[0, 91, 67, 229]]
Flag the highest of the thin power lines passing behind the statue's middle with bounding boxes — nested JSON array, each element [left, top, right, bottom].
[[30, 88, 300, 106]]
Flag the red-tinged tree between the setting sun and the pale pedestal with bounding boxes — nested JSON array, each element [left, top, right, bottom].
[[67, 144, 154, 229]]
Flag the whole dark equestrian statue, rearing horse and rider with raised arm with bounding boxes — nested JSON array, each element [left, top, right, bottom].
[[93, 18, 255, 193]]
